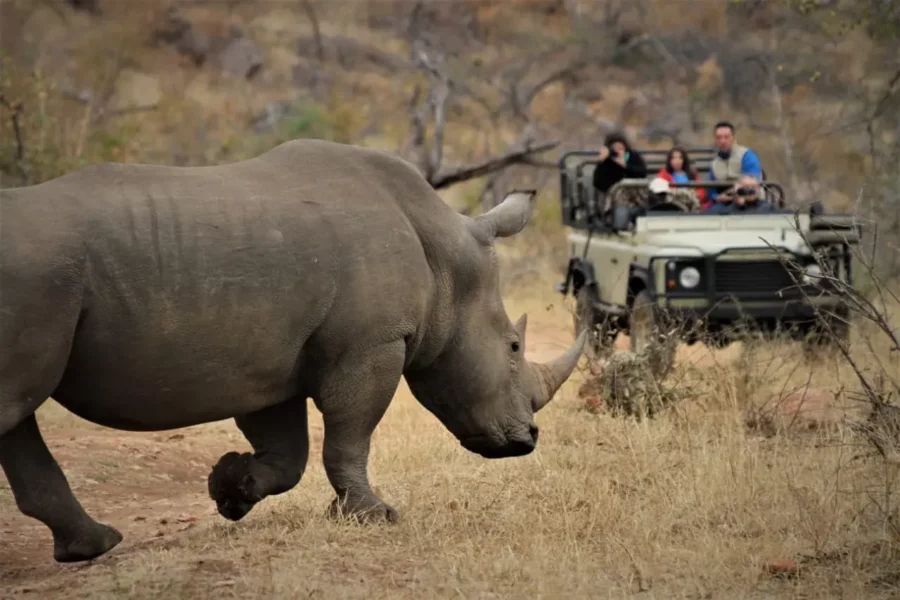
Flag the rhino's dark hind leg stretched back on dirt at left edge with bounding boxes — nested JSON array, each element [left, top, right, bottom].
[[0, 415, 122, 562]]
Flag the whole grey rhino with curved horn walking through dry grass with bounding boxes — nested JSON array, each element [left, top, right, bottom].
[[0, 141, 584, 562]]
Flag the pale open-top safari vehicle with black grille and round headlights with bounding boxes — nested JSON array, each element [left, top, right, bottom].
[[557, 148, 861, 359]]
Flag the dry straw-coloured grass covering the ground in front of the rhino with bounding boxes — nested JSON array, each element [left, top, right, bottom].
[[7, 247, 898, 598]]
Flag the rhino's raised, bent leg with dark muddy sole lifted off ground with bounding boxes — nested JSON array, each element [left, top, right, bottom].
[[209, 398, 309, 521]]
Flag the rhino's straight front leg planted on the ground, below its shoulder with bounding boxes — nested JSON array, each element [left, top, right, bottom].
[[320, 342, 406, 523]]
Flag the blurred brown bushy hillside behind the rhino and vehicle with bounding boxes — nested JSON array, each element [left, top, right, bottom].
[[0, 0, 900, 264]]
